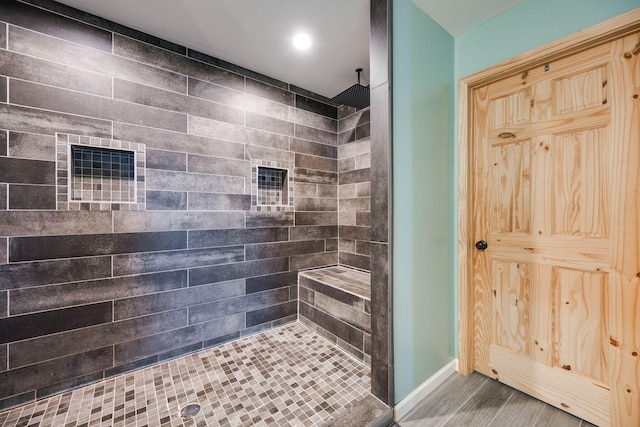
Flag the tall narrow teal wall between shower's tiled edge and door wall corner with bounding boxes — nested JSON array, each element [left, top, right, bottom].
[[392, 0, 455, 402]]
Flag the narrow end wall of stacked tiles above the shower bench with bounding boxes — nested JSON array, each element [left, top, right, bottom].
[[338, 106, 371, 271]]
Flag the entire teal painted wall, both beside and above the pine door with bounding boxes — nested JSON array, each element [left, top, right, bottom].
[[393, 0, 640, 402]]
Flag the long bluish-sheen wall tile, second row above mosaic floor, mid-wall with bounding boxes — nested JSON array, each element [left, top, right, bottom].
[[114, 313, 244, 365]]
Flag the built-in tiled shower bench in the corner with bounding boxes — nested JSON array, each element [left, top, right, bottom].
[[298, 265, 371, 364]]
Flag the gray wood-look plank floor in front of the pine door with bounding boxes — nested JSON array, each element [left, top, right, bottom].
[[397, 373, 593, 427]]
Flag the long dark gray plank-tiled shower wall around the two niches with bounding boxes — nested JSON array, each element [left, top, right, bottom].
[[0, 0, 356, 408]]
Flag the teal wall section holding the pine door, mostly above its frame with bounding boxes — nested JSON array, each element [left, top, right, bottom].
[[453, 0, 640, 357]]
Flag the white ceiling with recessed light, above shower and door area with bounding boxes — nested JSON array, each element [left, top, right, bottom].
[[57, 0, 522, 98]]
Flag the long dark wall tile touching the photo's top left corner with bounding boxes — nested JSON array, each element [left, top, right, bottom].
[[2, 0, 111, 52]]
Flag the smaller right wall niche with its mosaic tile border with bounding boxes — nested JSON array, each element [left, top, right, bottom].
[[251, 160, 294, 212]]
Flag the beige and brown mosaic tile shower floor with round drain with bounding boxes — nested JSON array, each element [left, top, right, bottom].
[[0, 323, 378, 427]]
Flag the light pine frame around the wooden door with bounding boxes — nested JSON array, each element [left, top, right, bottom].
[[458, 8, 640, 375]]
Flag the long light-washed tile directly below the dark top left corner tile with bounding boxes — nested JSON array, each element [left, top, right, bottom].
[[9, 27, 187, 93]]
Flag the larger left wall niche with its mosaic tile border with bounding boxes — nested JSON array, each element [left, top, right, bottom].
[[56, 133, 145, 211]]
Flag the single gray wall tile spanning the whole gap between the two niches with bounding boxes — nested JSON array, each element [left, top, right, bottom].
[[146, 169, 244, 194]]
